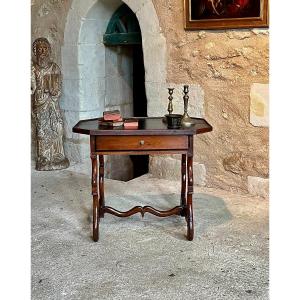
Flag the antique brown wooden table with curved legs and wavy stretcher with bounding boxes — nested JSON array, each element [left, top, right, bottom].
[[73, 118, 212, 242]]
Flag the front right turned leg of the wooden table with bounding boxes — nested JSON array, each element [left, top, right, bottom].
[[186, 136, 194, 241]]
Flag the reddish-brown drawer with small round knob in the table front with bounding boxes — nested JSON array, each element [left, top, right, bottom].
[[96, 135, 188, 151]]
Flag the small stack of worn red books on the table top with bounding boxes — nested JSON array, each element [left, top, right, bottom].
[[99, 110, 139, 129]]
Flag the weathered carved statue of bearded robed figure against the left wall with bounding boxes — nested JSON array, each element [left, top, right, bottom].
[[31, 38, 69, 171]]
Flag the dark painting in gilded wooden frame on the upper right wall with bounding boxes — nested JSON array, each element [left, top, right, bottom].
[[184, 0, 269, 30]]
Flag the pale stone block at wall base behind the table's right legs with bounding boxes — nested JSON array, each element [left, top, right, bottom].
[[149, 156, 206, 186]]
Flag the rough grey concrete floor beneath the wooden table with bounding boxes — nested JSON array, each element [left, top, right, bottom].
[[32, 170, 269, 300]]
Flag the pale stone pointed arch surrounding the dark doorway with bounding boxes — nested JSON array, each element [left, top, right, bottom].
[[61, 0, 167, 177]]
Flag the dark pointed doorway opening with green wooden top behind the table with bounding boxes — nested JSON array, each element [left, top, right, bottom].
[[103, 4, 149, 180]]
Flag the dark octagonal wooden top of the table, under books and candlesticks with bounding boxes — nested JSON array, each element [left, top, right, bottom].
[[73, 117, 213, 135]]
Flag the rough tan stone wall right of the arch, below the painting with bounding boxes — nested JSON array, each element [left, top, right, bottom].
[[154, 0, 269, 196]]
